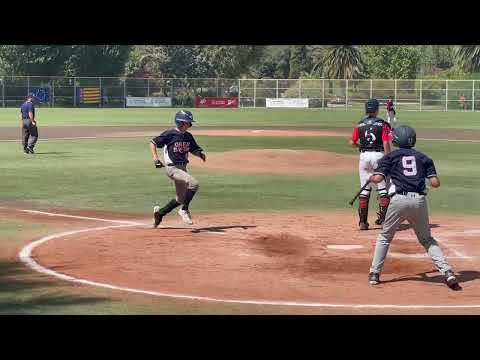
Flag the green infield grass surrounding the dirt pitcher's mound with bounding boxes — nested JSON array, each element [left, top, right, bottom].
[[0, 136, 480, 214]]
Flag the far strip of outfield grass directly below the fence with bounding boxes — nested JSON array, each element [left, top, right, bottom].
[[0, 108, 480, 129]]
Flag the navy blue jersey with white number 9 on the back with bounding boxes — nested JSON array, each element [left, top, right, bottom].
[[373, 148, 437, 193]]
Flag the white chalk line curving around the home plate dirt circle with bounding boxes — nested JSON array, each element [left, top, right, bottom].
[[13, 210, 480, 309]]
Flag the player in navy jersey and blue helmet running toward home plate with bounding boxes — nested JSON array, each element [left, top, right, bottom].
[[150, 110, 206, 228]]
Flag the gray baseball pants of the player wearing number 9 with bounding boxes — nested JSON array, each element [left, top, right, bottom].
[[370, 193, 451, 274]]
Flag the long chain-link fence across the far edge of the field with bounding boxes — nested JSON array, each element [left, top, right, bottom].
[[0, 76, 480, 111]]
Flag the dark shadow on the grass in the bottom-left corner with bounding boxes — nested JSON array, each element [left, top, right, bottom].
[[0, 260, 110, 315]]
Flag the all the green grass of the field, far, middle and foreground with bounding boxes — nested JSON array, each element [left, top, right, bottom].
[[0, 108, 480, 314]]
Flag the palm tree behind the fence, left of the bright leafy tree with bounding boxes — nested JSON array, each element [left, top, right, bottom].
[[322, 45, 363, 79]]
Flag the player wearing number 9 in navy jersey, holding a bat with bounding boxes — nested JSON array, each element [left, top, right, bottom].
[[369, 126, 459, 289]]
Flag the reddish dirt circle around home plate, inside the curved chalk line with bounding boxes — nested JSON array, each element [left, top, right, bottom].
[[25, 212, 480, 313]]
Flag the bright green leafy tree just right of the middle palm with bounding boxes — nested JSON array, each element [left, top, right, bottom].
[[362, 45, 421, 79]]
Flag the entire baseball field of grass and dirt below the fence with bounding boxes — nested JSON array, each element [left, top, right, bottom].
[[0, 108, 480, 314]]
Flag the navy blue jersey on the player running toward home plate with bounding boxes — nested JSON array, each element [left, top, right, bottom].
[[152, 128, 202, 165]]
